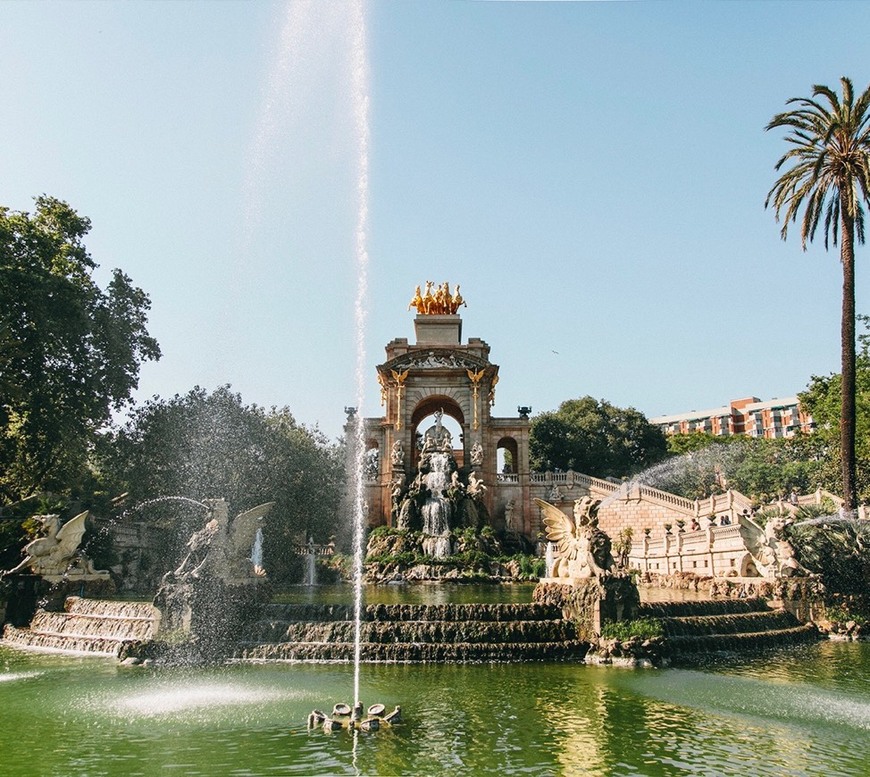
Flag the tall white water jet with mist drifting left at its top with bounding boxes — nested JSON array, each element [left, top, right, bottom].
[[243, 0, 369, 703]]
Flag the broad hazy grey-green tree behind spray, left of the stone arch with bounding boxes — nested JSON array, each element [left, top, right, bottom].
[[101, 386, 344, 582]]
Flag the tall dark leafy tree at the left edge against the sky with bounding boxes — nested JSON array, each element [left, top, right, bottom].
[[0, 196, 160, 502]]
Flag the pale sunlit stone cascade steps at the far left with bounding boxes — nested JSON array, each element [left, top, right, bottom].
[[3, 596, 159, 656]]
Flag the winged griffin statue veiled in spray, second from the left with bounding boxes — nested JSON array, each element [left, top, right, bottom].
[[175, 499, 275, 582]]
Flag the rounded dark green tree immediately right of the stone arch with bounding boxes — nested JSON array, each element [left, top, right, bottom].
[[529, 396, 667, 477]]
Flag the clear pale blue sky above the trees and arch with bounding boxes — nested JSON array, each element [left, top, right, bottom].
[[0, 0, 870, 437]]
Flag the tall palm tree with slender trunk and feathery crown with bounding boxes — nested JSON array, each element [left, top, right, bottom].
[[764, 77, 870, 511]]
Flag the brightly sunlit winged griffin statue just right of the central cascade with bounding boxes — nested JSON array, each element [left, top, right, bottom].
[[535, 496, 616, 579]]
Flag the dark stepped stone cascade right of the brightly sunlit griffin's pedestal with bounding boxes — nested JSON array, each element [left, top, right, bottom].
[[638, 598, 819, 658]]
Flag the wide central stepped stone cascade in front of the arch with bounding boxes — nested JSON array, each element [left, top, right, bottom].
[[236, 604, 589, 663]]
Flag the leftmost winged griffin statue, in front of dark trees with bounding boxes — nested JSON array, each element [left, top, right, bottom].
[[3, 510, 109, 578]]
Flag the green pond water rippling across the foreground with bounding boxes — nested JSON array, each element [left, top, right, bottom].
[[0, 642, 870, 777]]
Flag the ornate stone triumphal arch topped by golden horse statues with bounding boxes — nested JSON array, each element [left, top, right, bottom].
[[364, 282, 539, 540]]
